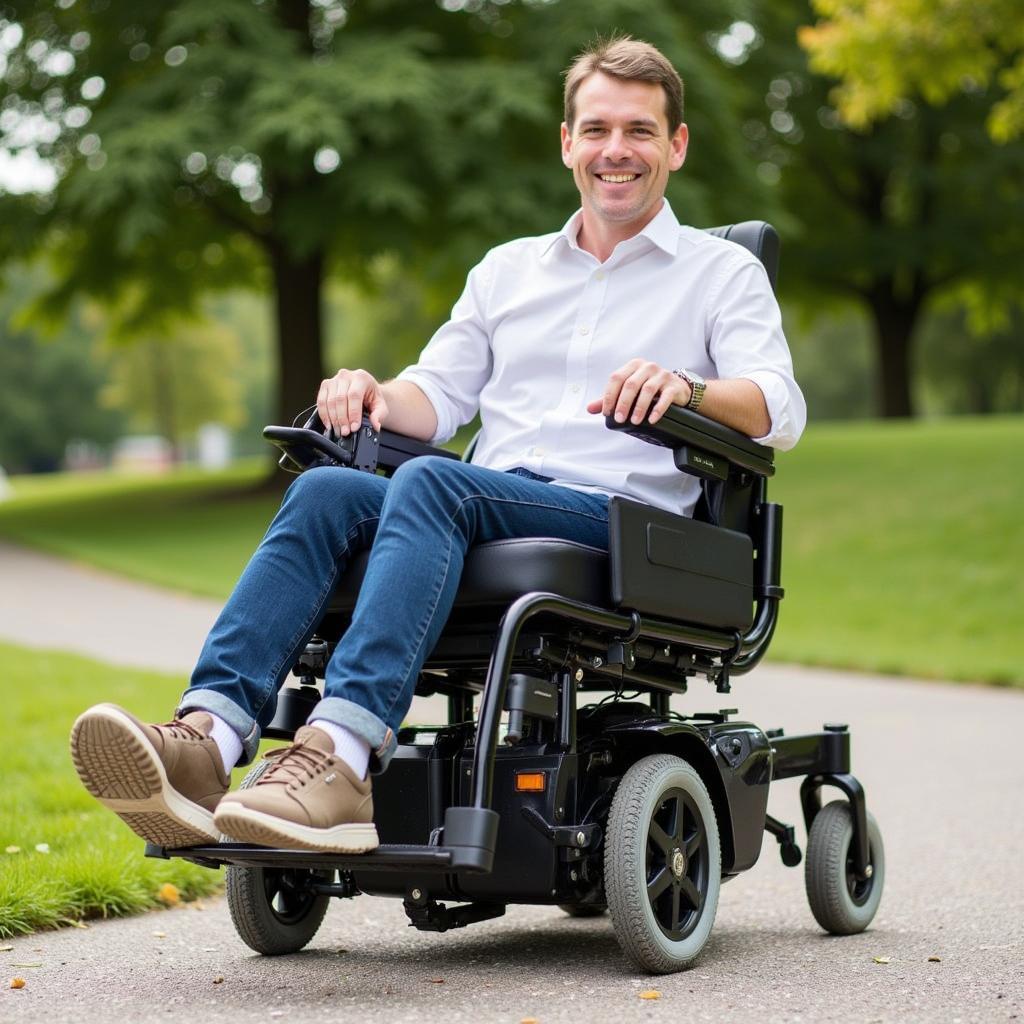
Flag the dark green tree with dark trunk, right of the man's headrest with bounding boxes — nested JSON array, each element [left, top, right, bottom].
[[740, 0, 1024, 417]]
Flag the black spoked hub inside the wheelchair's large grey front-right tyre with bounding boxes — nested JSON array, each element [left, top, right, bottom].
[[647, 790, 710, 942]]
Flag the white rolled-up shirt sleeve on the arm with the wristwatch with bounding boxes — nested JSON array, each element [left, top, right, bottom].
[[708, 254, 807, 452]]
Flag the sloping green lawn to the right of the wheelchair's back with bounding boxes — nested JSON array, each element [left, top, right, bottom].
[[771, 417, 1024, 686]]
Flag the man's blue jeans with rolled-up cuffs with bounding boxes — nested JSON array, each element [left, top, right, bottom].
[[177, 456, 608, 771]]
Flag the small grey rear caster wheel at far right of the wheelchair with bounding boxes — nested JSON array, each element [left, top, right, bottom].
[[804, 800, 886, 935]]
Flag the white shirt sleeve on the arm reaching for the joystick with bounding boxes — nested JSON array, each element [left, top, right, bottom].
[[396, 253, 493, 444]]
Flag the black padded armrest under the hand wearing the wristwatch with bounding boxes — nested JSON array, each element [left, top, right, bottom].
[[604, 406, 775, 480]]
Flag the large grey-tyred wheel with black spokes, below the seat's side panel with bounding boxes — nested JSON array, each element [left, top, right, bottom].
[[604, 754, 722, 974]]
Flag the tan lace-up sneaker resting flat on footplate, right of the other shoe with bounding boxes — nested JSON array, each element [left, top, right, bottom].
[[214, 725, 379, 853]]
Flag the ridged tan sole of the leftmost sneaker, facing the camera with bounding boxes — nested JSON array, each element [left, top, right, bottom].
[[71, 705, 220, 848]]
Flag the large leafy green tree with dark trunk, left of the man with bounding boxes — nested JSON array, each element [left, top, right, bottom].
[[0, 0, 763, 448]]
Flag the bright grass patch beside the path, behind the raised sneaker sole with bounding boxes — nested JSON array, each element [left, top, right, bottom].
[[0, 644, 280, 938]]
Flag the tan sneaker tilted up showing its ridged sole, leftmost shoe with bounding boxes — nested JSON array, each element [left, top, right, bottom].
[[71, 703, 230, 847]]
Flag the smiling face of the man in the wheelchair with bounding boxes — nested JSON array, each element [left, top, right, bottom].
[[562, 72, 687, 230]]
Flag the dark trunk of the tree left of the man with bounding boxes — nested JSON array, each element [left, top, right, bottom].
[[270, 243, 324, 425]]
